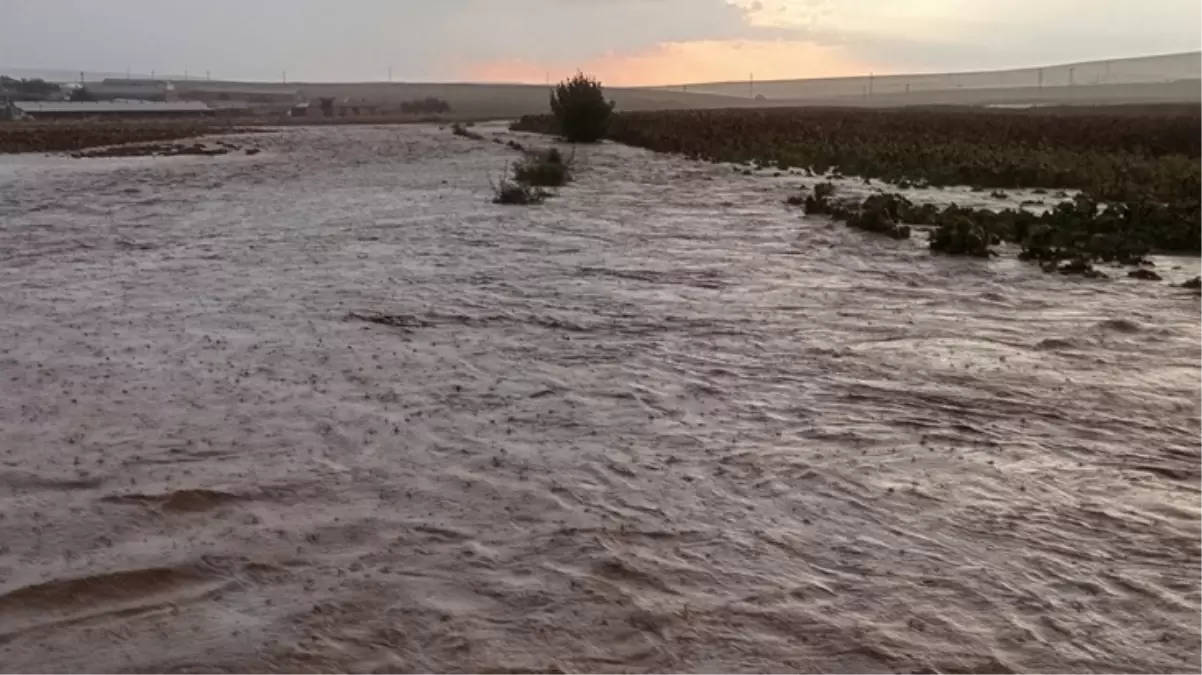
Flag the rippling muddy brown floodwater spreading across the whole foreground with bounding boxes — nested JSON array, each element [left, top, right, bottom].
[[0, 121, 1202, 675]]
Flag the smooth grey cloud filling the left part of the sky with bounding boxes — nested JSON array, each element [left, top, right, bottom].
[[0, 0, 792, 78]]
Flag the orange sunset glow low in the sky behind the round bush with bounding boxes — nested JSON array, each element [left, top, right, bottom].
[[458, 41, 871, 86]]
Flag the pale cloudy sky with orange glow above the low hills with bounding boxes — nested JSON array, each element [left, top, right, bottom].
[[7, 0, 1202, 85]]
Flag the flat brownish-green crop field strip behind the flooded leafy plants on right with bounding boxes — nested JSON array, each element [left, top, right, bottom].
[[514, 108, 1202, 201]]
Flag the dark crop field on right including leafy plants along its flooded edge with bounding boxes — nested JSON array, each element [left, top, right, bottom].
[[514, 107, 1202, 280]]
